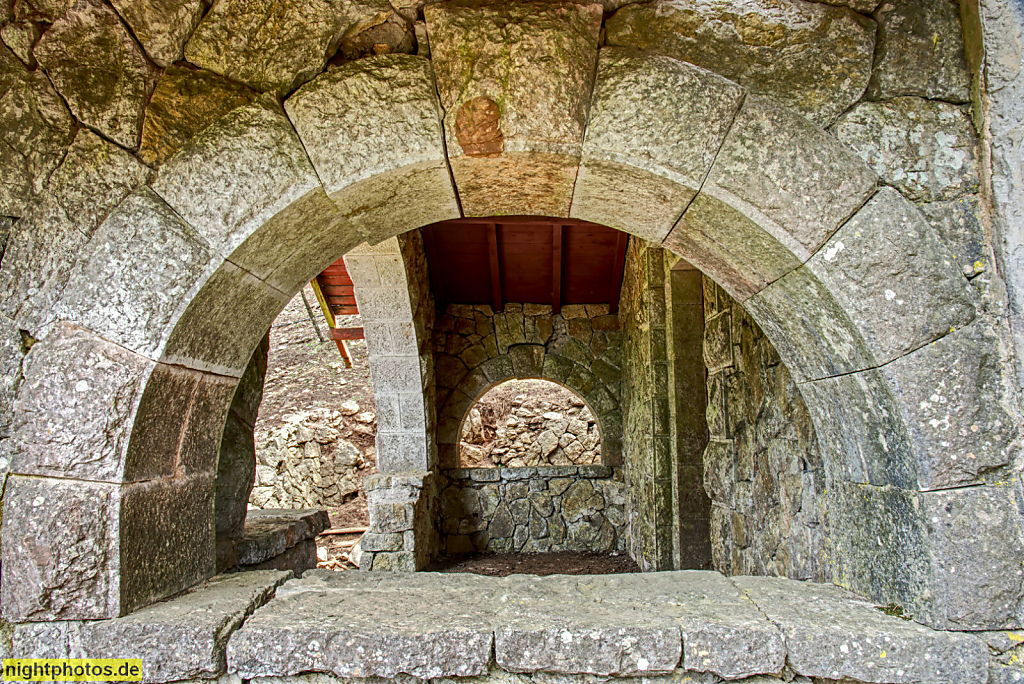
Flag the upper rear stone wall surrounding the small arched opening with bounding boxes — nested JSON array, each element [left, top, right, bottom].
[[433, 303, 622, 468]]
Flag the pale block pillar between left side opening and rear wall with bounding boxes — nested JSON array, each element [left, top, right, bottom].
[[345, 231, 437, 571]]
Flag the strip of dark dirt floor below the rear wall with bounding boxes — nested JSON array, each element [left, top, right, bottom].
[[427, 551, 640, 578]]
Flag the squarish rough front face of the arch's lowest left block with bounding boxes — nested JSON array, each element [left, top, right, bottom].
[[0, 475, 121, 623]]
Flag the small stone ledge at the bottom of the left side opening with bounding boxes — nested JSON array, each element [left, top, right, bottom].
[[238, 508, 331, 565]]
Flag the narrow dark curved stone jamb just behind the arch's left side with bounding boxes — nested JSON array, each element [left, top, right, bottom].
[[214, 334, 270, 570]]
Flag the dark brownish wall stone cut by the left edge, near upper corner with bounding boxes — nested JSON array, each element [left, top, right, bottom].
[[0, 71, 75, 216]]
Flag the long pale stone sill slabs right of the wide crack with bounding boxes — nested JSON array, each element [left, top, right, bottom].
[[227, 570, 988, 684]]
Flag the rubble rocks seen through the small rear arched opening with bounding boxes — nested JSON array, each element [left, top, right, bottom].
[[460, 395, 601, 468]]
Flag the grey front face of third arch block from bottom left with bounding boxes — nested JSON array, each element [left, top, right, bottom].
[[56, 186, 213, 358]]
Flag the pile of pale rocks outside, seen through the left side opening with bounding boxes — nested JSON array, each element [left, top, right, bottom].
[[249, 407, 374, 508]]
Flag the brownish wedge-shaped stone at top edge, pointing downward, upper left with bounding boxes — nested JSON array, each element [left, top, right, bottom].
[[112, 0, 207, 69]]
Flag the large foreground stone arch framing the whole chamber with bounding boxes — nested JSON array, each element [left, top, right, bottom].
[[3, 15, 1021, 629]]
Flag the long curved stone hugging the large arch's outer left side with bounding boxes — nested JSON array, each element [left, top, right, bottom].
[[0, 130, 148, 338]]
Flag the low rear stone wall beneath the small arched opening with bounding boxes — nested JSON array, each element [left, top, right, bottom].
[[439, 466, 627, 554]]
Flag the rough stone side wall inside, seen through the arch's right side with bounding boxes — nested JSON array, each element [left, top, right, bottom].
[[703, 276, 831, 582]]
